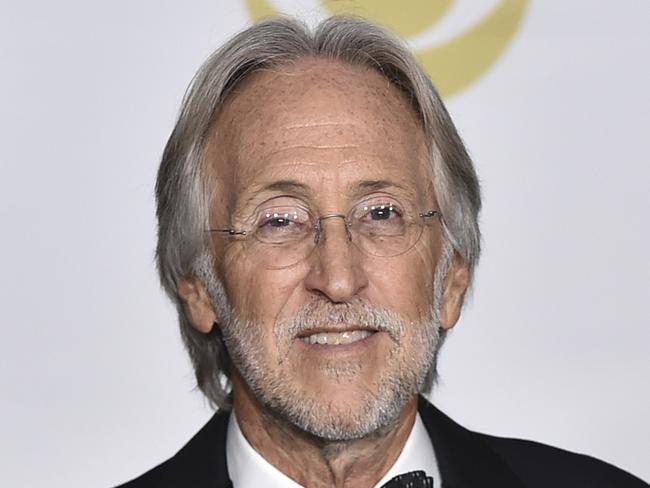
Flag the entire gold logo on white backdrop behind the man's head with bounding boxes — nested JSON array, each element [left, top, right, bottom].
[[244, 0, 526, 97]]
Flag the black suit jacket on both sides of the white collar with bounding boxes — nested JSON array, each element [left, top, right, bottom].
[[118, 398, 650, 488]]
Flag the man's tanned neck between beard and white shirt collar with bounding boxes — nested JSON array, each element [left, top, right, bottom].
[[233, 378, 417, 488]]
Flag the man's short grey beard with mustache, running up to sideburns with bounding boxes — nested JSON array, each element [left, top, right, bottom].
[[201, 246, 453, 442]]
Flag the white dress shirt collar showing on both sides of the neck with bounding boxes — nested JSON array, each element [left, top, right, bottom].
[[226, 411, 441, 488]]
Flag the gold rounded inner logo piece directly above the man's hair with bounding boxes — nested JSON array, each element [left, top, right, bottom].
[[321, 0, 452, 37]]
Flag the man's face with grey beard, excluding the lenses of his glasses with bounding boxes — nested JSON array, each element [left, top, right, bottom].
[[200, 60, 458, 439]]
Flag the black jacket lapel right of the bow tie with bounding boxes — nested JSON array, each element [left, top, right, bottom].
[[418, 397, 524, 488]]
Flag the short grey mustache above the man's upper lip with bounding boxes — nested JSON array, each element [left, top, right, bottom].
[[275, 298, 406, 342]]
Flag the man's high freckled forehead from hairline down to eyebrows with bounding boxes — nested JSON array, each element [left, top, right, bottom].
[[208, 60, 430, 206]]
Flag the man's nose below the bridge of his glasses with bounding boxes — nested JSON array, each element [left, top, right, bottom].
[[305, 215, 368, 303]]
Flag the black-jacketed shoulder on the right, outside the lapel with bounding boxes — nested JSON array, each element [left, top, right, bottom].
[[473, 433, 648, 488]]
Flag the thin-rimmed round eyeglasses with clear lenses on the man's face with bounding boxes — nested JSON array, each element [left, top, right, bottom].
[[208, 197, 441, 269]]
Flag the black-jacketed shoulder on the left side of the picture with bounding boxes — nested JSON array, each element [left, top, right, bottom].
[[116, 412, 230, 488]]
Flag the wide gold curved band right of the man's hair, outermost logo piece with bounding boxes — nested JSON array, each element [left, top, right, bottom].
[[416, 0, 526, 97]]
